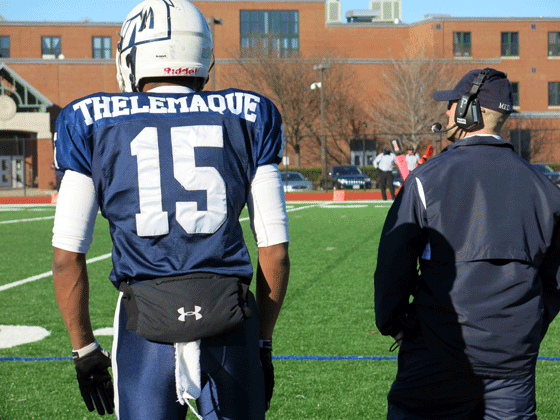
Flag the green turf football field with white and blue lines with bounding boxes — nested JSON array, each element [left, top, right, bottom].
[[0, 202, 560, 420]]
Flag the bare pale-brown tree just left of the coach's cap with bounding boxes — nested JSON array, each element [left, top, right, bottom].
[[370, 55, 457, 149]]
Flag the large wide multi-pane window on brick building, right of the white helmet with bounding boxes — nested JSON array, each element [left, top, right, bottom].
[[240, 10, 299, 57]]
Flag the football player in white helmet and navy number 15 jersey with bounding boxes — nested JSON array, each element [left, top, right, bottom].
[[52, 0, 289, 420]]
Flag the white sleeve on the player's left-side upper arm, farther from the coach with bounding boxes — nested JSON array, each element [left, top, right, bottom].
[[52, 170, 99, 254]]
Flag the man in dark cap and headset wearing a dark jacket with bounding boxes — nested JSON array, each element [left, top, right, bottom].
[[375, 68, 560, 420]]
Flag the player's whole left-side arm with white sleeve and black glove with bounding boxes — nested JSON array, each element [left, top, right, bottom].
[[52, 171, 114, 415]]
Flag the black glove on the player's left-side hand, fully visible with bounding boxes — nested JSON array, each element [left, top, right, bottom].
[[72, 347, 114, 415]]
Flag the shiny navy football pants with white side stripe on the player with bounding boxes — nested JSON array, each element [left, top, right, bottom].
[[113, 293, 265, 420]]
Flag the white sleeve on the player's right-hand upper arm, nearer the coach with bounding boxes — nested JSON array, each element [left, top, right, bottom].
[[247, 165, 290, 248]]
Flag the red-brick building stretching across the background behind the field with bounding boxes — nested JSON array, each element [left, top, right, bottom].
[[0, 0, 560, 189]]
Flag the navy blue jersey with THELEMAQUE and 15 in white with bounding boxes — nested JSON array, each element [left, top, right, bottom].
[[55, 89, 284, 284]]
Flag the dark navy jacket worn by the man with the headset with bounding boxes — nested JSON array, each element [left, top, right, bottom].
[[375, 136, 560, 377]]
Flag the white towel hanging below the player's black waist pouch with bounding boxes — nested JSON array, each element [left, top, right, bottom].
[[175, 340, 203, 420]]
